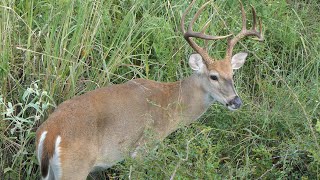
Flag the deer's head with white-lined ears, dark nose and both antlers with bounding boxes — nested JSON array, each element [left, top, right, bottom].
[[181, 0, 263, 110]]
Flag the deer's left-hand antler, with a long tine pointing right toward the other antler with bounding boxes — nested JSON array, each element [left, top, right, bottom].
[[181, 0, 231, 65]]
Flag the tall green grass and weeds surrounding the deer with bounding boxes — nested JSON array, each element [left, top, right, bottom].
[[0, 0, 320, 179]]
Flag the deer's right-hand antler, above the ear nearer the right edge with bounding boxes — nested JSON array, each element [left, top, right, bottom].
[[226, 1, 263, 59]]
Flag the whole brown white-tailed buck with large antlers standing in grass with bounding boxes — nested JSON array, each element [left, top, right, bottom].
[[36, 0, 263, 180]]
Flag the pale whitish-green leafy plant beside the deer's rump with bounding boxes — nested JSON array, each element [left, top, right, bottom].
[[0, 82, 56, 179]]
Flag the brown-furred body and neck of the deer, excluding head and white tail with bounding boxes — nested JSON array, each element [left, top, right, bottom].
[[37, 75, 218, 179]]
